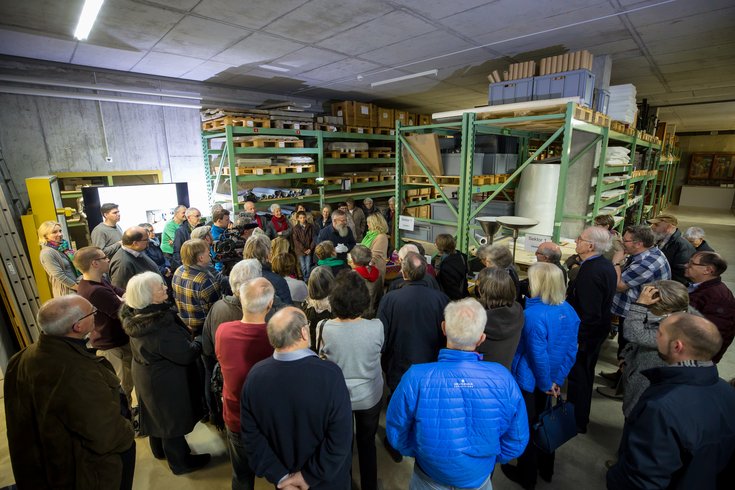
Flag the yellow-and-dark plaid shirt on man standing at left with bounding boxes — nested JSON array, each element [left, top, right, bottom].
[[171, 265, 220, 334]]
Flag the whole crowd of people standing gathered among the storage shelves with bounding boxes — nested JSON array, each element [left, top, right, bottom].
[[5, 199, 735, 490]]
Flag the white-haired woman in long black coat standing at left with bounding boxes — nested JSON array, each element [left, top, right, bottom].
[[120, 272, 210, 475]]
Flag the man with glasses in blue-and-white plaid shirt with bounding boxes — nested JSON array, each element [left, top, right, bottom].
[[602, 225, 671, 392]]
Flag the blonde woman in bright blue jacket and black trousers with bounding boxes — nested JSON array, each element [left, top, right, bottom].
[[501, 262, 579, 489]]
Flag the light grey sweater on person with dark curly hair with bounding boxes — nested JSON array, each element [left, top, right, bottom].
[[317, 319, 384, 410]]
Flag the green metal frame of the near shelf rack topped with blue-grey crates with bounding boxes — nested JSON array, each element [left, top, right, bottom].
[[394, 102, 663, 252]]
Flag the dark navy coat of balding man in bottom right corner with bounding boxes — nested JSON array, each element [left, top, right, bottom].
[[607, 366, 735, 490]]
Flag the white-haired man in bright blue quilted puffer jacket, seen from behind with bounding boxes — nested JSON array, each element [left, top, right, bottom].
[[386, 298, 528, 490]]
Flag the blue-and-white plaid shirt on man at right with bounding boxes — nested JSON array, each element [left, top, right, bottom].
[[612, 246, 671, 317]]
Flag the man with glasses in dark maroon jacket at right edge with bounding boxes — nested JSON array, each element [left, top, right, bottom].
[[684, 252, 735, 363]]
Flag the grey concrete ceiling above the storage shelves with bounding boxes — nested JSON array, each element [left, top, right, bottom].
[[0, 0, 735, 132]]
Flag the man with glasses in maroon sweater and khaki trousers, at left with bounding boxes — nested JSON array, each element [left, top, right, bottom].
[[74, 247, 133, 402]]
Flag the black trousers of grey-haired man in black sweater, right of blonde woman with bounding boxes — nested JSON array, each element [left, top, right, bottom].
[[567, 336, 606, 430]]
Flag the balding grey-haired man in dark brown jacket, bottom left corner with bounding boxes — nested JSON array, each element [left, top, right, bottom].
[[5, 295, 135, 489]]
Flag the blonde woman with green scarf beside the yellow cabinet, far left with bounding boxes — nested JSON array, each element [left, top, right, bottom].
[[38, 221, 81, 298]]
